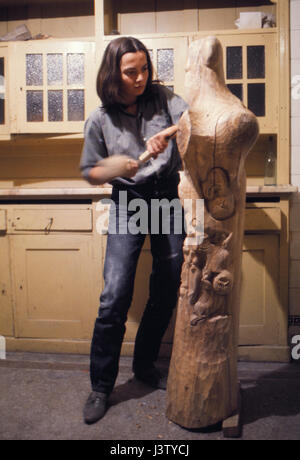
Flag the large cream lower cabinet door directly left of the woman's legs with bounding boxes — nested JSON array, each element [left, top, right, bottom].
[[12, 235, 95, 339]]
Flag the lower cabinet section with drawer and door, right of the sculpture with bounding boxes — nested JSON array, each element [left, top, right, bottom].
[[239, 202, 290, 361]]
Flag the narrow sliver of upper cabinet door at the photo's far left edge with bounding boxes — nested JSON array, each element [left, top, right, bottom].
[[0, 45, 9, 139]]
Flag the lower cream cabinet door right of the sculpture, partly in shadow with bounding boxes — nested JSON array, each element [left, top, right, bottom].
[[239, 234, 281, 345]]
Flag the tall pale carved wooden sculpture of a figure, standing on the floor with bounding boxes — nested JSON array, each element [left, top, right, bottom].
[[167, 37, 258, 428]]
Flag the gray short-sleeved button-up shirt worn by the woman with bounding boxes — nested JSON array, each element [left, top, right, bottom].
[[80, 85, 187, 187]]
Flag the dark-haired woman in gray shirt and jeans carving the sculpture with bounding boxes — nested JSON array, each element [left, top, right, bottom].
[[80, 37, 187, 423]]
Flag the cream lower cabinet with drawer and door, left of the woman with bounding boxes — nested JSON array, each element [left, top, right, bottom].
[[0, 203, 102, 353]]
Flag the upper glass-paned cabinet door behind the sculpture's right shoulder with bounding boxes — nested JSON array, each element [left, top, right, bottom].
[[218, 33, 279, 133]]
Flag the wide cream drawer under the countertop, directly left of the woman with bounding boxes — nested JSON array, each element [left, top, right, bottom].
[[11, 209, 93, 233]]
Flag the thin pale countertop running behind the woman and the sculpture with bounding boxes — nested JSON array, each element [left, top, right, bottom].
[[0, 185, 298, 199]]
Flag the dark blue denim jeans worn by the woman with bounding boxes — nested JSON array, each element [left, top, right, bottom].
[[90, 174, 185, 394]]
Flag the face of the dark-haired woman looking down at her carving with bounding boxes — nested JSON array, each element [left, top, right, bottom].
[[120, 51, 149, 105]]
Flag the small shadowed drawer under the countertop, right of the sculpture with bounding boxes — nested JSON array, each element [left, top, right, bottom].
[[245, 208, 281, 232]]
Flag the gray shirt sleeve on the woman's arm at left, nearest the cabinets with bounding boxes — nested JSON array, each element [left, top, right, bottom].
[[80, 110, 108, 180]]
